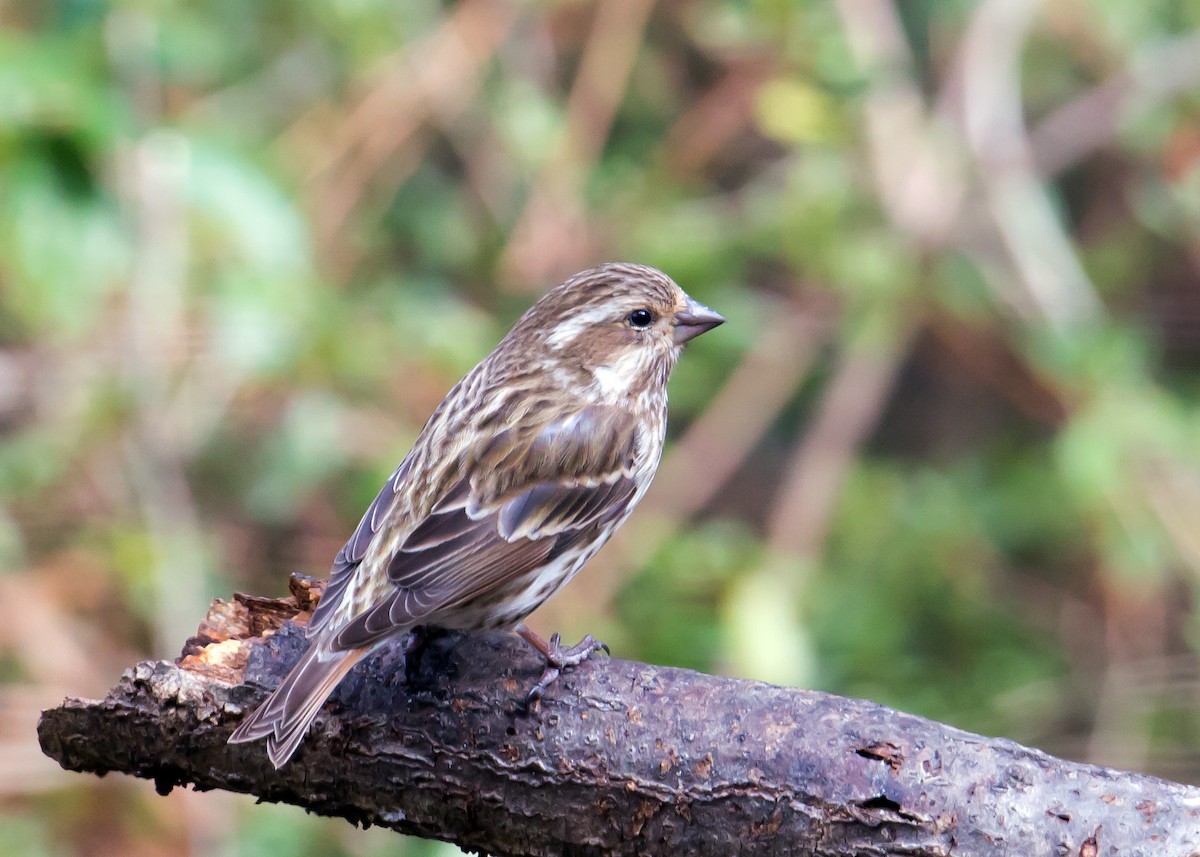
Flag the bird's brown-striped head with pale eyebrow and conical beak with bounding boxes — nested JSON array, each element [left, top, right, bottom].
[[512, 263, 725, 402]]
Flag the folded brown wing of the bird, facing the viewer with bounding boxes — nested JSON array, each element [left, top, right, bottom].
[[334, 406, 638, 648]]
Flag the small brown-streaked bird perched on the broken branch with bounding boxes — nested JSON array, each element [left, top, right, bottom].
[[229, 256, 725, 769]]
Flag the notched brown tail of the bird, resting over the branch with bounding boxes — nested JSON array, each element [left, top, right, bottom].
[[229, 639, 370, 768]]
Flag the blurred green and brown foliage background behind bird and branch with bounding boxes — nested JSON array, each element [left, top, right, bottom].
[[0, 0, 1200, 857]]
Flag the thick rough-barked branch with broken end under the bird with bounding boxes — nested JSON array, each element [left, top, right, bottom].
[[38, 579, 1200, 857]]
